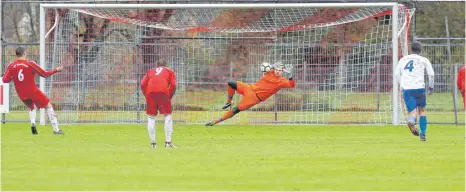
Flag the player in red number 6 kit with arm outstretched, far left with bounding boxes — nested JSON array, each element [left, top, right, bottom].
[[2, 47, 64, 135]]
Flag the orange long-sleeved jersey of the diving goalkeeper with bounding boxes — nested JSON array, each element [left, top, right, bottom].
[[252, 70, 295, 101]]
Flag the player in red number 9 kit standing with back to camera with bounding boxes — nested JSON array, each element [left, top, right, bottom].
[[141, 60, 176, 148]]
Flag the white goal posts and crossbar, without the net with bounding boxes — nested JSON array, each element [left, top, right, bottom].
[[39, 2, 408, 125]]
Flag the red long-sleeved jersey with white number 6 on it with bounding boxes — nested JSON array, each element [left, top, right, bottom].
[[2, 59, 57, 100]]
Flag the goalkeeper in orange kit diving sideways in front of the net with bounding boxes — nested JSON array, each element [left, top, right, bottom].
[[206, 62, 295, 126]]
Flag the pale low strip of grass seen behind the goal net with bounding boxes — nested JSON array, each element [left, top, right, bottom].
[[6, 110, 465, 125]]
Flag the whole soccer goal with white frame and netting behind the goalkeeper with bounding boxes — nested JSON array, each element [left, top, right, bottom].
[[40, 3, 413, 124]]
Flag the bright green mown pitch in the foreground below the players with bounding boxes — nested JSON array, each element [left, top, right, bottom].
[[1, 123, 465, 191]]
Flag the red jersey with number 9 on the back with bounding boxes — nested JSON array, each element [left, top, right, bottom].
[[141, 67, 176, 96]]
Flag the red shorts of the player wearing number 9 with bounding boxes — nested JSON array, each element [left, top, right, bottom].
[[146, 92, 172, 116]]
